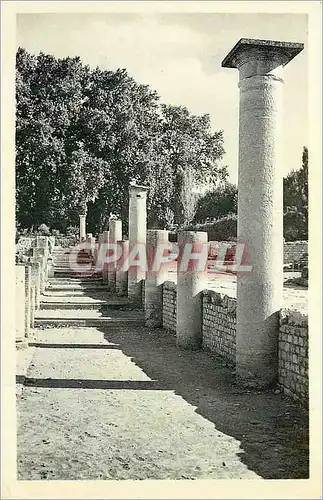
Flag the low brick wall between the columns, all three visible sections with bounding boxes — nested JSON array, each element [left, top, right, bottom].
[[158, 281, 308, 401]]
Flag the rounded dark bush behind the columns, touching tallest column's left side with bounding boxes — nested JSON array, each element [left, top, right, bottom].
[[194, 181, 238, 223]]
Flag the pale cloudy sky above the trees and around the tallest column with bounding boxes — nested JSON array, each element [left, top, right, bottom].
[[17, 13, 308, 183]]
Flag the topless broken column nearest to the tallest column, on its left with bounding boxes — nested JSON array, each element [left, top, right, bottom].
[[176, 231, 208, 349]]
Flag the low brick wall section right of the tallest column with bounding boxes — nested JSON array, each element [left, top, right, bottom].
[[278, 309, 308, 400]]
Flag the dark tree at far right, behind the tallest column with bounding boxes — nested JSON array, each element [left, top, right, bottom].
[[284, 146, 308, 241]]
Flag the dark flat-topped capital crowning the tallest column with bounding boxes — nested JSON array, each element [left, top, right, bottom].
[[221, 38, 304, 79]]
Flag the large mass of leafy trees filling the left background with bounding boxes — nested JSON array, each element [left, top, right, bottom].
[[16, 48, 226, 232]]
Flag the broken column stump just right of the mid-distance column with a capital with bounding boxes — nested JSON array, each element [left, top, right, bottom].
[[145, 229, 168, 328]]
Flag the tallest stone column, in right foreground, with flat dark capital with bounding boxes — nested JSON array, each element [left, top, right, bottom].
[[222, 38, 303, 387]]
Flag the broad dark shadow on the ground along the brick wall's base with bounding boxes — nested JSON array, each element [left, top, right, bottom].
[[85, 326, 309, 479]]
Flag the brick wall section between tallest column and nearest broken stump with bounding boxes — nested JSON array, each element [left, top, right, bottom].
[[202, 290, 237, 364]]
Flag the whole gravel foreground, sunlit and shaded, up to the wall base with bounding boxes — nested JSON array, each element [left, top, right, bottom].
[[17, 327, 308, 480]]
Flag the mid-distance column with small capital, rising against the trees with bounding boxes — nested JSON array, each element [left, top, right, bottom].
[[128, 185, 148, 303]]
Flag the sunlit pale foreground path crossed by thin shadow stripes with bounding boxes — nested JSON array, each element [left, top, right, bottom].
[[19, 328, 257, 479]]
